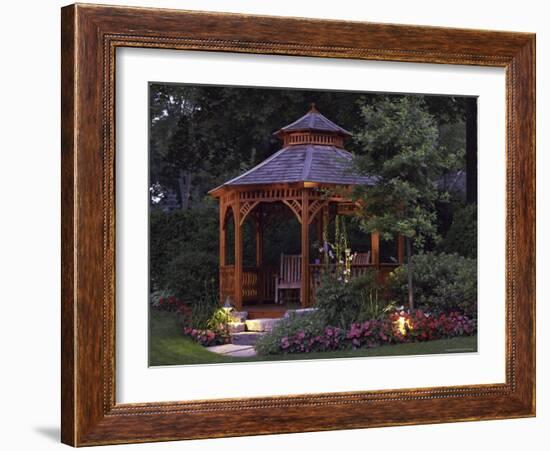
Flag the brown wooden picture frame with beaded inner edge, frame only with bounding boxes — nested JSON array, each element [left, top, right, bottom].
[[61, 4, 535, 446]]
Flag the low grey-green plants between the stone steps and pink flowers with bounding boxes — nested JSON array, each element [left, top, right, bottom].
[[255, 311, 327, 355]]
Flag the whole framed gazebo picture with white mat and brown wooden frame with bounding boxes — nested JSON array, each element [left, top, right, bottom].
[[61, 5, 535, 446]]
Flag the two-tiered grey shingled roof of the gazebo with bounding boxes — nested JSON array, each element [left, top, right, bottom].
[[211, 104, 375, 194]]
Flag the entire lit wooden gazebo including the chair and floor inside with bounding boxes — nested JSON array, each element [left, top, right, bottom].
[[210, 105, 404, 316]]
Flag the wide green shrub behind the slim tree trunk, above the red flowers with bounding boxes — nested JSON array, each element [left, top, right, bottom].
[[388, 253, 477, 318]]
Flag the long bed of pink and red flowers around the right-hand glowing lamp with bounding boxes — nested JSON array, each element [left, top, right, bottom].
[[256, 310, 476, 355]]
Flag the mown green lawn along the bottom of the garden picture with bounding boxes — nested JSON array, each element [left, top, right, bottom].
[[149, 310, 477, 366]]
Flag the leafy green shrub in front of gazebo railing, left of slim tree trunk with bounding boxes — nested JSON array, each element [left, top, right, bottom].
[[316, 270, 387, 328]]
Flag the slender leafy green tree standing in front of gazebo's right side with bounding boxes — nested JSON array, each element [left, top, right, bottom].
[[354, 96, 460, 309]]
